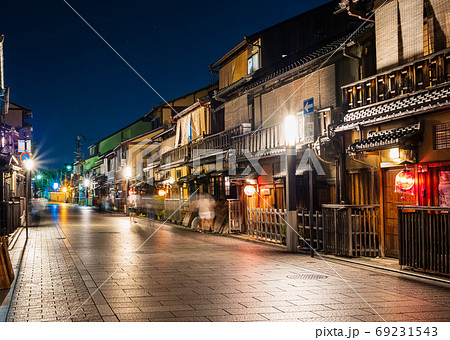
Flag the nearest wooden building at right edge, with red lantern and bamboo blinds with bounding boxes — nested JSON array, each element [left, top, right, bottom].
[[338, 0, 450, 272]]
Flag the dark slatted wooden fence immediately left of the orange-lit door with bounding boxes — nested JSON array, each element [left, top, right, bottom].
[[322, 204, 380, 257]]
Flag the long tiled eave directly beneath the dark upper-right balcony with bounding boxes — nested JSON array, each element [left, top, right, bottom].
[[334, 83, 450, 132]]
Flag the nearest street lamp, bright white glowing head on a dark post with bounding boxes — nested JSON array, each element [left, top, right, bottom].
[[284, 115, 298, 253]]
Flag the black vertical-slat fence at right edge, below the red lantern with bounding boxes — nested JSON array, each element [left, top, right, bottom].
[[398, 206, 450, 274]]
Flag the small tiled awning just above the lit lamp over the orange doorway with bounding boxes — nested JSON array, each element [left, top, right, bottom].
[[348, 123, 421, 152]]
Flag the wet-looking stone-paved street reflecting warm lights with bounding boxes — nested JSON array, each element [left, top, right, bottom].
[[8, 205, 450, 321]]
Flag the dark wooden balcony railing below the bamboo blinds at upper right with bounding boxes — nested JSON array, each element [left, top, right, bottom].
[[342, 49, 450, 110]]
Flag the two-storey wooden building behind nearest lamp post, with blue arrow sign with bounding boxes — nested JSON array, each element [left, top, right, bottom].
[[210, 2, 374, 241]]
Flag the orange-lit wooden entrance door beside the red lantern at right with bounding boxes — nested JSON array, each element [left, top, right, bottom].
[[383, 168, 416, 257]]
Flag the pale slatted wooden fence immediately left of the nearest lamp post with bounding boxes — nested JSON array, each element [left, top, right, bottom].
[[247, 208, 286, 244]]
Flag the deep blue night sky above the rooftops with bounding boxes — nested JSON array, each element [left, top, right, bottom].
[[0, 0, 327, 167]]
